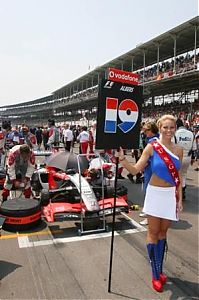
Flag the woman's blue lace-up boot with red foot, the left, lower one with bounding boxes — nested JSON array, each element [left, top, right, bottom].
[[147, 244, 162, 292]]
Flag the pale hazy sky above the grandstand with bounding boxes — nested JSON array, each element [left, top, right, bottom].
[[0, 0, 199, 106]]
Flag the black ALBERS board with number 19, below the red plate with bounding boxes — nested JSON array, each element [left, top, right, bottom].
[[95, 79, 142, 149]]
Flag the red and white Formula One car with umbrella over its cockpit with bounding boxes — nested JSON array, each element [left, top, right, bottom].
[[31, 152, 128, 222]]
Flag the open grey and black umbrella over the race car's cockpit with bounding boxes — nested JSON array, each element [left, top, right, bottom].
[[46, 151, 89, 172]]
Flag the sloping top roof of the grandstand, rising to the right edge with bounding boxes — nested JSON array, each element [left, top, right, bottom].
[[53, 16, 199, 94]]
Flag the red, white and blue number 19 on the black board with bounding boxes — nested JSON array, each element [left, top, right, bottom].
[[104, 97, 139, 133]]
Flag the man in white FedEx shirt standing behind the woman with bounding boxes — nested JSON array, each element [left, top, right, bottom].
[[175, 119, 196, 200]]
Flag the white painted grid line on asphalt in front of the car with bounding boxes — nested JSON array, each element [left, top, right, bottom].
[[18, 213, 146, 248]]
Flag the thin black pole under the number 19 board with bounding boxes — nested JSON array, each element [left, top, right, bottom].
[[108, 157, 119, 293]]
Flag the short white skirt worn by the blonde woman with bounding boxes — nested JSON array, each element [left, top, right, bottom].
[[143, 184, 179, 221]]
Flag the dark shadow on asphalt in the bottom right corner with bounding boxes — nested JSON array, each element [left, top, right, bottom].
[[164, 277, 199, 300]]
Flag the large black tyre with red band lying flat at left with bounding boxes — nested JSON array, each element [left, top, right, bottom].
[[0, 197, 41, 231]]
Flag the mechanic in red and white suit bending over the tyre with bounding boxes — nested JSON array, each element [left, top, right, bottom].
[[2, 144, 35, 201]]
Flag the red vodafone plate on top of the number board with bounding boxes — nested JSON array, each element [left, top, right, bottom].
[[108, 68, 139, 85]]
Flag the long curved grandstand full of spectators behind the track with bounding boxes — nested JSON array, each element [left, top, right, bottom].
[[0, 16, 199, 125]]
